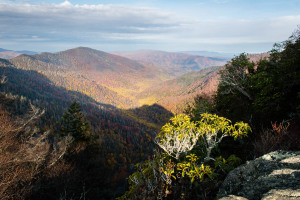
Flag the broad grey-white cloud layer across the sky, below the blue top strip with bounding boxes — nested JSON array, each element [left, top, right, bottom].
[[0, 1, 300, 52]]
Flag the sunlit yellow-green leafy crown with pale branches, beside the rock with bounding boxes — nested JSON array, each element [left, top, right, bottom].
[[156, 113, 251, 160]]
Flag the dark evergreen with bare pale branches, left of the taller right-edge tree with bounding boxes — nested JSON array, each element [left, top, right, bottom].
[[214, 53, 255, 122]]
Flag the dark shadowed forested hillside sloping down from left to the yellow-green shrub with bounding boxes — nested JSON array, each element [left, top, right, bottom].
[[0, 60, 172, 199]]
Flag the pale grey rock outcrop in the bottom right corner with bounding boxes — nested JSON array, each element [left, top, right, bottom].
[[217, 151, 300, 200]]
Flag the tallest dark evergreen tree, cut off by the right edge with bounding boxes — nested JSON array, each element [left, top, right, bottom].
[[251, 29, 300, 123]]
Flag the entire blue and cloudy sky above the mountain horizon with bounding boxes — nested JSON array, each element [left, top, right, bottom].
[[0, 0, 300, 53]]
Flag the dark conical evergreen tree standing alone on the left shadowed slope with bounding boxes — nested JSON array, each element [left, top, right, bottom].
[[62, 101, 90, 142]]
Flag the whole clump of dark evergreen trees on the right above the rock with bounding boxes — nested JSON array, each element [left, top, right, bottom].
[[214, 30, 300, 127]]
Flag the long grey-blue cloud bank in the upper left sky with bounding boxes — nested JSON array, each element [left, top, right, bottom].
[[0, 1, 175, 32]]
